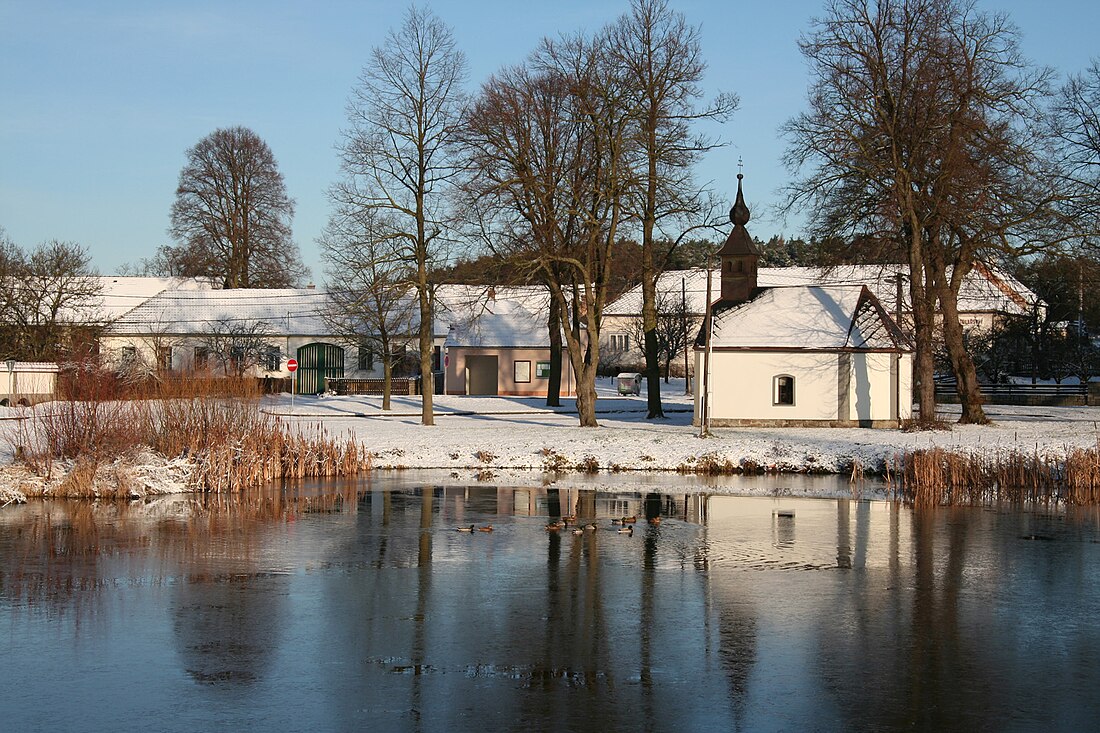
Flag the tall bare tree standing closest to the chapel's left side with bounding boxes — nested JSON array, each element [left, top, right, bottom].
[[606, 0, 738, 418]]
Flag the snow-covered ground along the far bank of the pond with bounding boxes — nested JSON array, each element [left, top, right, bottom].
[[0, 379, 1100, 504]]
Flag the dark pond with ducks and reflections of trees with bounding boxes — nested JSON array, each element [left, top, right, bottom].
[[0, 478, 1100, 732]]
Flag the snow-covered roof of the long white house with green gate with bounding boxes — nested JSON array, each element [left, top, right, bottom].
[[111, 287, 331, 335]]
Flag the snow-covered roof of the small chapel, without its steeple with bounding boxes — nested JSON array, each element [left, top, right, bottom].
[[711, 285, 908, 350]]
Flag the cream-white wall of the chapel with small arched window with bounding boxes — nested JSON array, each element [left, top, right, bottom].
[[694, 350, 912, 427]]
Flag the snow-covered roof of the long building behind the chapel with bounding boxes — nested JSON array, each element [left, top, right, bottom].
[[604, 264, 1038, 316]]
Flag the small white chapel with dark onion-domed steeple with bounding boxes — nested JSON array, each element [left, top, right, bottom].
[[695, 174, 912, 427]]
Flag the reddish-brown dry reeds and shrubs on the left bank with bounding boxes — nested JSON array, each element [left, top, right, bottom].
[[9, 369, 371, 496]]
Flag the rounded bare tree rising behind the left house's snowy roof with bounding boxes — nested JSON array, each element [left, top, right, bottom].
[[167, 127, 307, 287]]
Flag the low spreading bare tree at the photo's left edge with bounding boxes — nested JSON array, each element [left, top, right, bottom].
[[0, 238, 107, 361]]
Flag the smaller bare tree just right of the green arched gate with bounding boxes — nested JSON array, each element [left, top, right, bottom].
[[320, 200, 416, 409]]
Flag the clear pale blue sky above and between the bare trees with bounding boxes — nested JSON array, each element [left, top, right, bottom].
[[0, 0, 1100, 283]]
